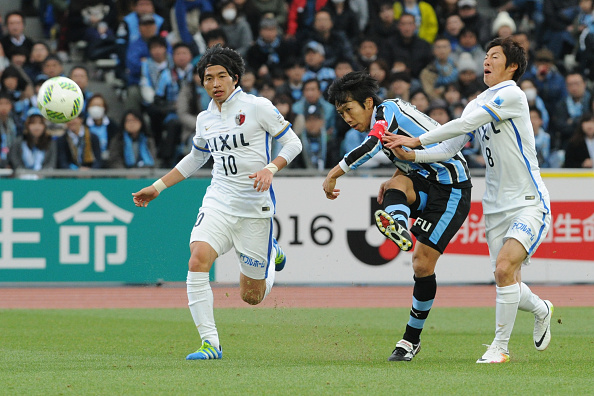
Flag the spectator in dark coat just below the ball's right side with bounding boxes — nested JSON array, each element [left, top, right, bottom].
[[56, 116, 102, 170]]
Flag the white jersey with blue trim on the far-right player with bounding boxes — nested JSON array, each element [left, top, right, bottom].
[[461, 80, 550, 214]]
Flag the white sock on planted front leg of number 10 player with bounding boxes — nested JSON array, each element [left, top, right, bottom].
[[186, 271, 219, 349]]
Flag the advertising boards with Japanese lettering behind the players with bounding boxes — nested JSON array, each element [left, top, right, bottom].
[[0, 173, 594, 285]]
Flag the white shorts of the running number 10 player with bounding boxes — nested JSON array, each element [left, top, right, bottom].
[[190, 208, 274, 279]]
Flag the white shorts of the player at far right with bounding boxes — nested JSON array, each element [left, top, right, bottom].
[[485, 206, 551, 271]]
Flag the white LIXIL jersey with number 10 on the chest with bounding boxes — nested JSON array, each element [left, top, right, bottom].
[[193, 87, 291, 218]]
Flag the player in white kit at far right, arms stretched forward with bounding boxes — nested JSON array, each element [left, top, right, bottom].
[[385, 38, 553, 363]]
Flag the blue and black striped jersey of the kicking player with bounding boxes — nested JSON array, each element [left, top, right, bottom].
[[344, 99, 472, 188]]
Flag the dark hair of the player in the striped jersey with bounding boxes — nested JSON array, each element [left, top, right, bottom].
[[328, 71, 382, 107]]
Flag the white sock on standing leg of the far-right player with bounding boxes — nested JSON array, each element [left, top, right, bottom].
[[493, 283, 520, 350]]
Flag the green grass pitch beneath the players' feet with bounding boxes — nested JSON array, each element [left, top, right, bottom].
[[0, 307, 594, 396]]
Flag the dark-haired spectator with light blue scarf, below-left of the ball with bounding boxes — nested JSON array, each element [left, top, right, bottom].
[[8, 113, 58, 171]]
